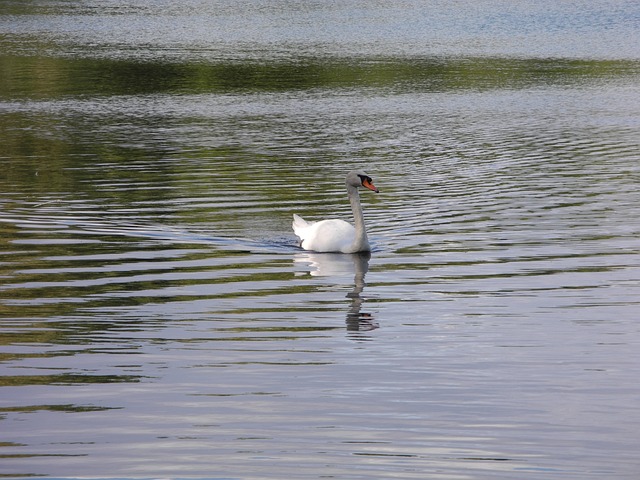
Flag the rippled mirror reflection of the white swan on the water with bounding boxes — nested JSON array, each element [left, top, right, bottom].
[[294, 252, 379, 332]]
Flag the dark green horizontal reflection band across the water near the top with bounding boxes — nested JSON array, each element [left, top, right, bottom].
[[0, 56, 640, 98]]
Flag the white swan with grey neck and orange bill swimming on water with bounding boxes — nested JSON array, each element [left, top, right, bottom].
[[293, 171, 379, 253]]
